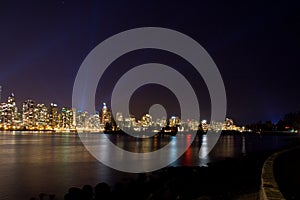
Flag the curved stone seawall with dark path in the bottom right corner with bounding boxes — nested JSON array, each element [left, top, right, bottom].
[[259, 147, 300, 200]]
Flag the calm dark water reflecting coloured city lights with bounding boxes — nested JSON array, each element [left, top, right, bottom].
[[0, 132, 299, 199]]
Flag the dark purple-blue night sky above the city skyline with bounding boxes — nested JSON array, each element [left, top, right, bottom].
[[0, 0, 300, 123]]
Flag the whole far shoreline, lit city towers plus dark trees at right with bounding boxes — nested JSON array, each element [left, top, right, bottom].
[[0, 89, 300, 133]]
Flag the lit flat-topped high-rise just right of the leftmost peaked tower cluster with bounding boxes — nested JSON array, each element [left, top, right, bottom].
[[22, 99, 36, 128]]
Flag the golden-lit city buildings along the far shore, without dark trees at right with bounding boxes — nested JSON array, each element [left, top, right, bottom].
[[0, 94, 245, 132]]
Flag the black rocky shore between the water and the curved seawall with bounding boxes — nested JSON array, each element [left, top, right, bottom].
[[32, 152, 272, 200]]
